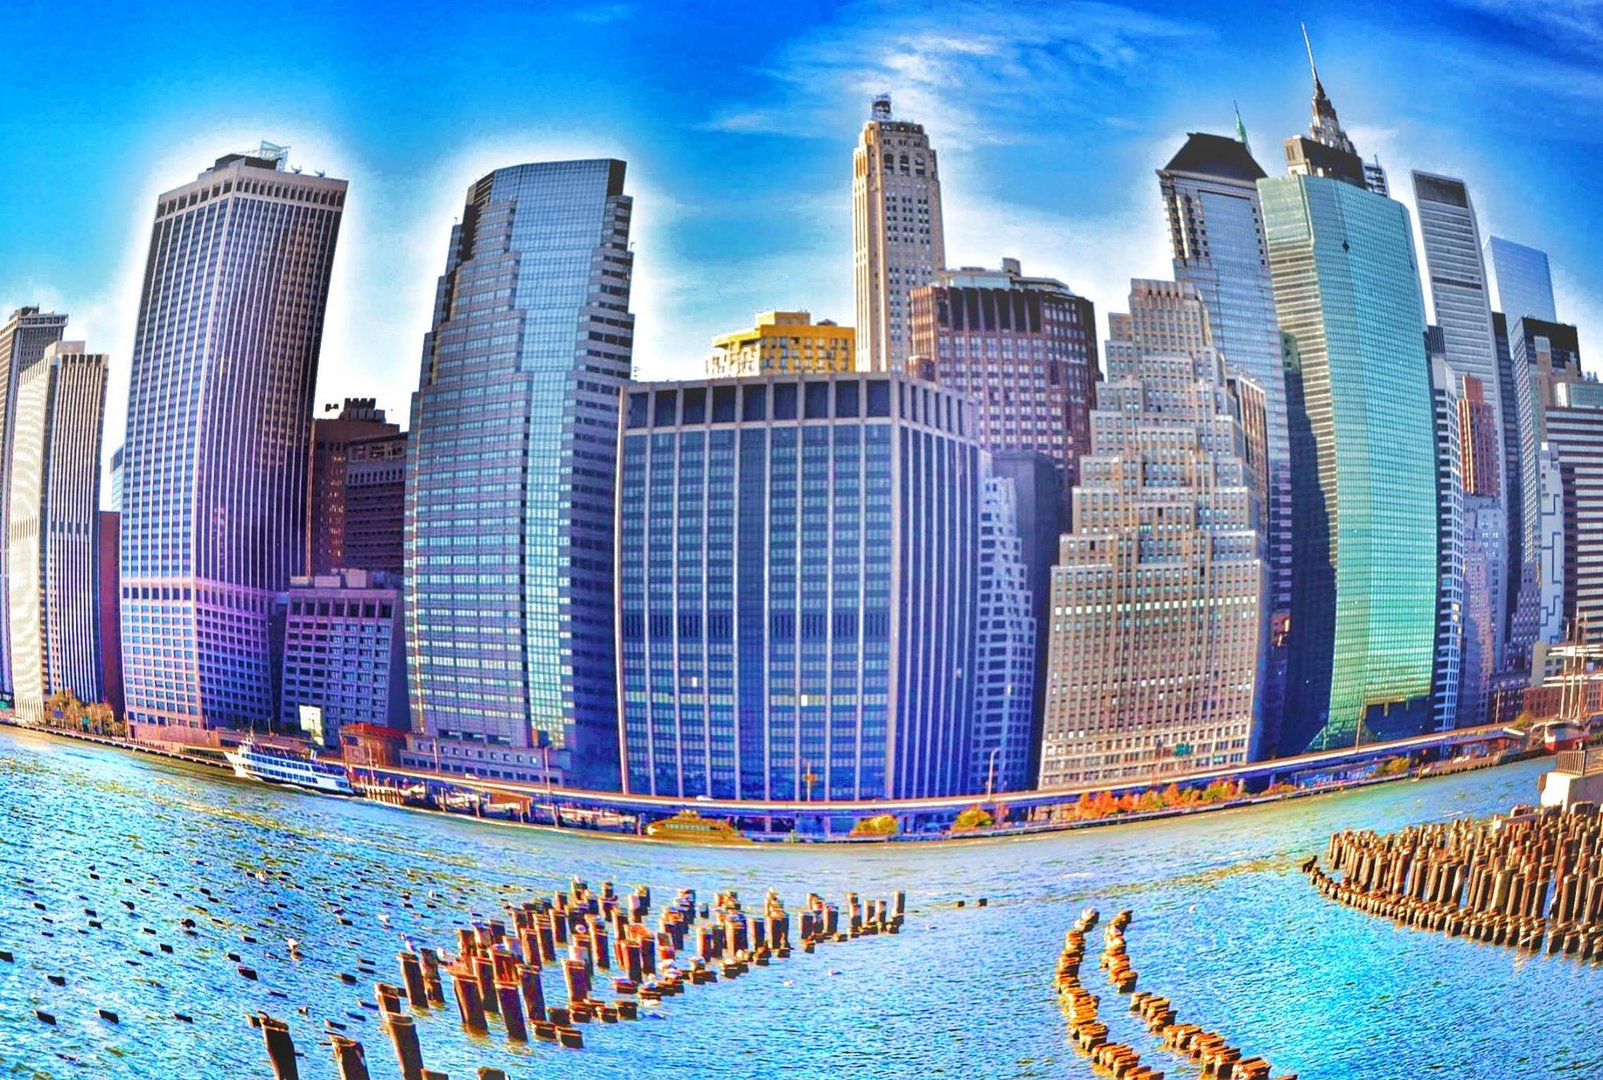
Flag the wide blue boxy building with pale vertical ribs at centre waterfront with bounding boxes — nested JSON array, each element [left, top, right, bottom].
[[617, 373, 983, 800]]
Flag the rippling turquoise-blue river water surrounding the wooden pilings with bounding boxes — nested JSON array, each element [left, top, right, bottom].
[[0, 731, 1583, 1080]]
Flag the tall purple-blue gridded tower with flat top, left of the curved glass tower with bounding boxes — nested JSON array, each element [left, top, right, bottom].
[[120, 143, 346, 737]]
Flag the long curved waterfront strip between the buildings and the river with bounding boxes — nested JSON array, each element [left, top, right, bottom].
[[0, 719, 1542, 849]]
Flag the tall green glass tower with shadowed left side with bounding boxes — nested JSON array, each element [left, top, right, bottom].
[[1258, 173, 1436, 753]]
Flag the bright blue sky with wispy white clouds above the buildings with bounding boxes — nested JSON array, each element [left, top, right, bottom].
[[0, 0, 1603, 453]]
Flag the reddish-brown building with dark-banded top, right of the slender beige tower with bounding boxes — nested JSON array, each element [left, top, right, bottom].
[[907, 258, 1096, 495]]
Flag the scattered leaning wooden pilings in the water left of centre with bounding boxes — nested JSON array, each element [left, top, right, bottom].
[[250, 878, 907, 1080]]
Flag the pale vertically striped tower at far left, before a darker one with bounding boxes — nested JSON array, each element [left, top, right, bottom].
[[6, 341, 106, 721]]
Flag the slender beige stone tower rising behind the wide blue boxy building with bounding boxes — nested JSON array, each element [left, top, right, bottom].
[[851, 95, 946, 372]]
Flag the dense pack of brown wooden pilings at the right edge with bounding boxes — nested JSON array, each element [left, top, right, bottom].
[[1302, 803, 1603, 960]]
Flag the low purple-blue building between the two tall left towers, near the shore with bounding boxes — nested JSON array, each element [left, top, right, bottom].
[[279, 569, 409, 747]]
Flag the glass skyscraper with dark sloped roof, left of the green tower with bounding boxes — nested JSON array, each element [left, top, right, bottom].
[[1157, 128, 1295, 753]]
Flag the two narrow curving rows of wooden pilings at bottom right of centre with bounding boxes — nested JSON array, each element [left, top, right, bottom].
[[1055, 909, 1297, 1080]]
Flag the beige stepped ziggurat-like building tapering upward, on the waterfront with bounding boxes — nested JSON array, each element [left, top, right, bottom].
[[1040, 280, 1265, 787]]
